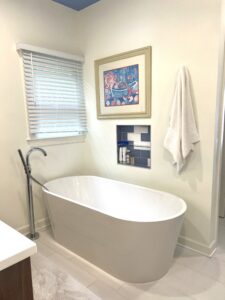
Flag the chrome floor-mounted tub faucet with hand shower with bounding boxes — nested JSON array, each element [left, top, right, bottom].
[[18, 147, 47, 240]]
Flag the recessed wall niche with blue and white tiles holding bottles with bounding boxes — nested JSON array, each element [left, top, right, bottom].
[[117, 125, 151, 169]]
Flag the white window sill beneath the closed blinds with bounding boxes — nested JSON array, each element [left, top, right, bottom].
[[27, 134, 86, 146]]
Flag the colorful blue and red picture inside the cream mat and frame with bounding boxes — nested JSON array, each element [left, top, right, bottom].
[[103, 64, 139, 107]]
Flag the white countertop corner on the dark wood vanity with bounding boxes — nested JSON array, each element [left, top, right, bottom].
[[0, 221, 37, 271]]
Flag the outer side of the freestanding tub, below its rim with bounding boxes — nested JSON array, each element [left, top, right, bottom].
[[48, 197, 185, 283]]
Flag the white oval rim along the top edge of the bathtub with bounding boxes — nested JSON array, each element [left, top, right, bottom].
[[42, 175, 187, 223]]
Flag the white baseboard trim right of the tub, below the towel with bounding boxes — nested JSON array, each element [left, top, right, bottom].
[[177, 236, 217, 257]]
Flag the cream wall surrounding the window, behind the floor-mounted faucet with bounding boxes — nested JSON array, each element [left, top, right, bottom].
[[0, 0, 84, 228]]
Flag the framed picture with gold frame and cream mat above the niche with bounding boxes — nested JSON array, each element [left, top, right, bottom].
[[95, 47, 151, 119]]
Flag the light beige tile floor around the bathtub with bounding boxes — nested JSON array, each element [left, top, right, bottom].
[[31, 219, 225, 300]]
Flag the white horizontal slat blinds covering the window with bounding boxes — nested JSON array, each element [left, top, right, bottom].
[[22, 50, 87, 138]]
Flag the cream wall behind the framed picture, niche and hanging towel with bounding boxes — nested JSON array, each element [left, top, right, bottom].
[[81, 0, 220, 253]]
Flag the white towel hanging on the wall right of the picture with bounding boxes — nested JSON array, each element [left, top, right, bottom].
[[164, 67, 199, 173]]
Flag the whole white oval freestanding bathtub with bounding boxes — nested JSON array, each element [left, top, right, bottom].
[[44, 176, 186, 283]]
